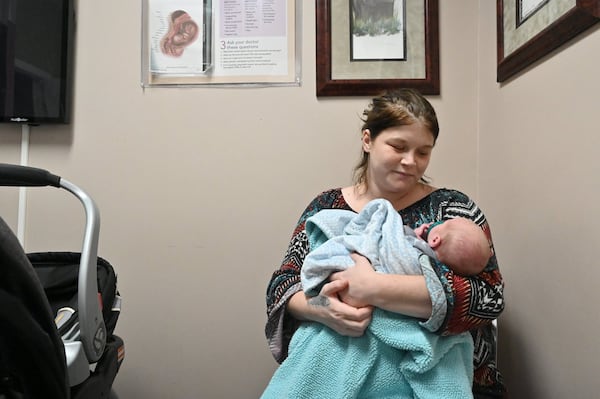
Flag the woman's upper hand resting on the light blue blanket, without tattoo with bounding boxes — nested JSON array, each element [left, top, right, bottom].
[[330, 253, 377, 307]]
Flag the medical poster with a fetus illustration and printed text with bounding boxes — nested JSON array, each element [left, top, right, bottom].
[[142, 0, 300, 87]]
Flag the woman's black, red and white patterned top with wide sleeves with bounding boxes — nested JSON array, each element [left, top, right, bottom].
[[265, 188, 504, 396]]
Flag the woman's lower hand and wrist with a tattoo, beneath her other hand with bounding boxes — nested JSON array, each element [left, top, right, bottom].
[[288, 280, 373, 337]]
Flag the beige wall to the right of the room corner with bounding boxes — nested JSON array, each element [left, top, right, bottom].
[[477, 1, 600, 399]]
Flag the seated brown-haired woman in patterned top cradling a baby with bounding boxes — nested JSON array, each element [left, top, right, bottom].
[[265, 89, 504, 398]]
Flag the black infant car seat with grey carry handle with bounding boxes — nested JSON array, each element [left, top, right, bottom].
[[0, 164, 125, 399]]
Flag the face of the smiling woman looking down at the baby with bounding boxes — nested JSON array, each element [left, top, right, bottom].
[[362, 122, 434, 194]]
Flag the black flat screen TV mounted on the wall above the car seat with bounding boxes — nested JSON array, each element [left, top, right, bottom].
[[0, 0, 75, 125]]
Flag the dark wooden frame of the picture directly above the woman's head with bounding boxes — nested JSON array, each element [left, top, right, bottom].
[[316, 0, 440, 97]]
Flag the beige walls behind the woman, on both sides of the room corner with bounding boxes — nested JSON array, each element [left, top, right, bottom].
[[0, 0, 600, 399]]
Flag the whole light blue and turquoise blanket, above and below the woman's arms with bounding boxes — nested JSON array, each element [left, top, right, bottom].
[[262, 200, 473, 399]]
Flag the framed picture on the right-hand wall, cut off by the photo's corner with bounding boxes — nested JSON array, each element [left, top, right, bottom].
[[496, 0, 600, 82]]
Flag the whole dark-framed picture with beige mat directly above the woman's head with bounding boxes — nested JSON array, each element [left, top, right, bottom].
[[316, 0, 440, 97]]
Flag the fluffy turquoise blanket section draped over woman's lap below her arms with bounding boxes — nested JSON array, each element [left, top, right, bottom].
[[261, 309, 473, 399]]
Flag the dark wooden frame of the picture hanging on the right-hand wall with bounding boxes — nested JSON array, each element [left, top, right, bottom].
[[496, 0, 600, 82]]
